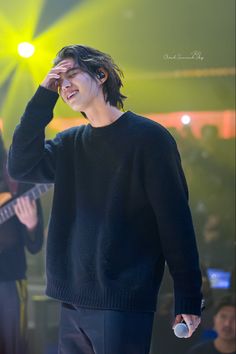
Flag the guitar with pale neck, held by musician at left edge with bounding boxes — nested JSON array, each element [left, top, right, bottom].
[[0, 184, 53, 225]]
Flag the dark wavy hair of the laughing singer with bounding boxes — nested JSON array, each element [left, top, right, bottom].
[[54, 44, 127, 109]]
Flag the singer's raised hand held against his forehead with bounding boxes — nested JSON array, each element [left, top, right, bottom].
[[41, 60, 73, 92]]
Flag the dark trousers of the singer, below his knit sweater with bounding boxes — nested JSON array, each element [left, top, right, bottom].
[[58, 304, 154, 354]]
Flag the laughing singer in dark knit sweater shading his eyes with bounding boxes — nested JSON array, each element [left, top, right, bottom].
[[9, 45, 201, 354]]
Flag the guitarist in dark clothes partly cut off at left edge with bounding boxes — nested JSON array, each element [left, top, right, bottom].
[[0, 132, 43, 354]]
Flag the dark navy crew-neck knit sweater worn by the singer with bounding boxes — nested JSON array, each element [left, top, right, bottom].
[[8, 87, 201, 314]]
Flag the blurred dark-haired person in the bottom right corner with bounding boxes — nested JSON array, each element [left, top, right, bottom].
[[189, 296, 236, 354]]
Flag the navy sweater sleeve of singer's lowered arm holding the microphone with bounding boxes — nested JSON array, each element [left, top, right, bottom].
[[145, 132, 202, 315]]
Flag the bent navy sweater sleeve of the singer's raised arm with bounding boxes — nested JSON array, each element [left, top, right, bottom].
[[8, 86, 60, 183]]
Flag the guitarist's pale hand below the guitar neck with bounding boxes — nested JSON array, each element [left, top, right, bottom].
[[14, 197, 38, 230]]
